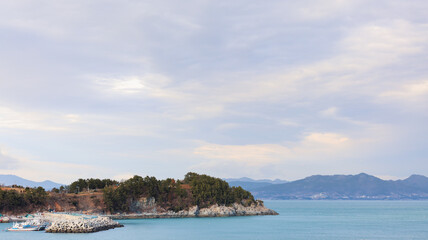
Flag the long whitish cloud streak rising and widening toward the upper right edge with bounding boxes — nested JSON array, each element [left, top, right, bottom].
[[165, 20, 428, 109]]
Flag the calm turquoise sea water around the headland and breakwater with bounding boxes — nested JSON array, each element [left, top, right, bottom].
[[0, 201, 428, 240]]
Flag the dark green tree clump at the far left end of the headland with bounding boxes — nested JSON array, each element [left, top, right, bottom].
[[0, 187, 48, 211]]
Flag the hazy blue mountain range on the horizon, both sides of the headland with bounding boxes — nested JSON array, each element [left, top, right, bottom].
[[0, 173, 428, 200]]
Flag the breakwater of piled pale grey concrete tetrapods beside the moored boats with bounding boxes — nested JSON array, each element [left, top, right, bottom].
[[45, 214, 123, 233]]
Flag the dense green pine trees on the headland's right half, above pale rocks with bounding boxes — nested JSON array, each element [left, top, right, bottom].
[[104, 173, 255, 212]]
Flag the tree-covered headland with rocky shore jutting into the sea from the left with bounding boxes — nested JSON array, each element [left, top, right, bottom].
[[0, 172, 278, 232]]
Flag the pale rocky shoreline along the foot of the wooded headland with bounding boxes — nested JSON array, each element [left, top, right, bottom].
[[108, 203, 278, 220]]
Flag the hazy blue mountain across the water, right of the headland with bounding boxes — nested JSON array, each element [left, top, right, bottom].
[[244, 173, 428, 200]]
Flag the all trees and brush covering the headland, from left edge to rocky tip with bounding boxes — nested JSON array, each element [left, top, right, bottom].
[[0, 172, 255, 213]]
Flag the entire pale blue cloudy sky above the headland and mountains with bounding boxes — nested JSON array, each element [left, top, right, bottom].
[[0, 0, 428, 184]]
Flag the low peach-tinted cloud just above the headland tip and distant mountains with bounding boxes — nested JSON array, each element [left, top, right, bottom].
[[189, 133, 356, 179]]
